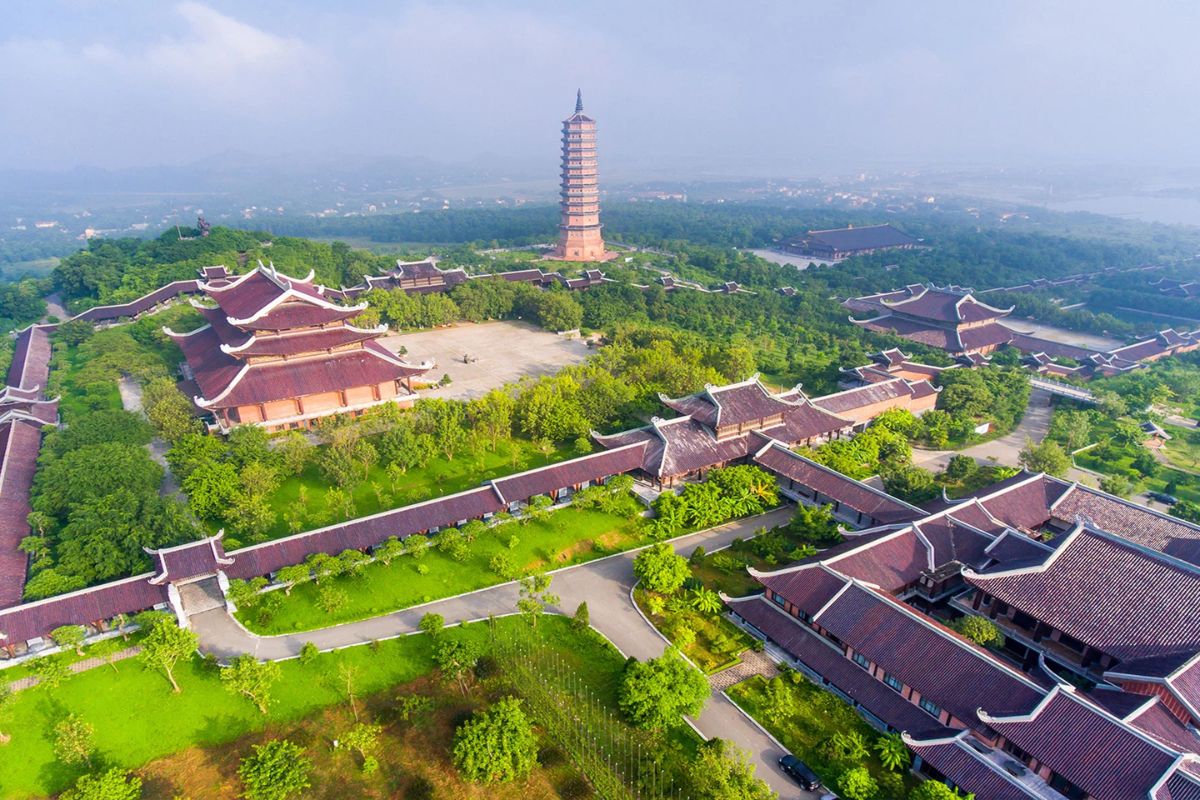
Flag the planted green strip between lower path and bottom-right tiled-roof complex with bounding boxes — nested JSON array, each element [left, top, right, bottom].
[[728, 674, 917, 796]]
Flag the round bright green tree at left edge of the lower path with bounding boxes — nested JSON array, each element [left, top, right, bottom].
[[618, 648, 709, 729]]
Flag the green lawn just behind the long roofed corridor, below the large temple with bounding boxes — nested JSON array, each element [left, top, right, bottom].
[[225, 439, 576, 549]]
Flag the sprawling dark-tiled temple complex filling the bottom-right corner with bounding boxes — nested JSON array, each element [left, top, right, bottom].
[[727, 462, 1200, 800]]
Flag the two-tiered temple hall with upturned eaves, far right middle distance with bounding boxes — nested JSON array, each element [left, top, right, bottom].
[[842, 283, 1014, 355]]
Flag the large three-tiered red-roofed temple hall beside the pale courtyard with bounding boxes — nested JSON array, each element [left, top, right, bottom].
[[166, 261, 433, 431]]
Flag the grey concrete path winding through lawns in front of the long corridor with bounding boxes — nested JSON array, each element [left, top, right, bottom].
[[191, 506, 816, 798]]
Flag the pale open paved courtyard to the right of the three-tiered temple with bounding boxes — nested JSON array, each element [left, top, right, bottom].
[[379, 321, 592, 399]]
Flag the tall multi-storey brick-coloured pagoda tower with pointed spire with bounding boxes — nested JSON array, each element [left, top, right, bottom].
[[551, 90, 614, 261]]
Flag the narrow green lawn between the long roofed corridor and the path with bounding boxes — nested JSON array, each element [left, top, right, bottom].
[[238, 507, 648, 633]]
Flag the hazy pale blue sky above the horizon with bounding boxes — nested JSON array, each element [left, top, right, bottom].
[[0, 0, 1200, 173]]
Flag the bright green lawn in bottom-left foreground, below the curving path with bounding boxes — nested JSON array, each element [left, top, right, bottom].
[[0, 616, 624, 798]]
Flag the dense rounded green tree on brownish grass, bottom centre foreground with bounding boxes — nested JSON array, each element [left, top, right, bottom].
[[454, 697, 538, 783]]
